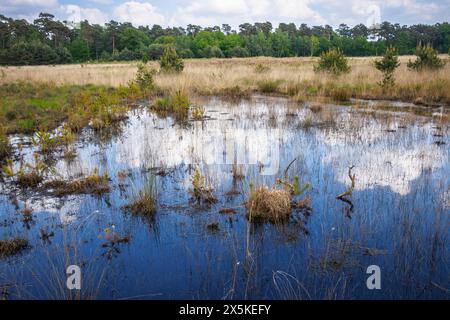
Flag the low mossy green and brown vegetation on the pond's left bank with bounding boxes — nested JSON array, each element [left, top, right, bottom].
[[0, 82, 143, 134]]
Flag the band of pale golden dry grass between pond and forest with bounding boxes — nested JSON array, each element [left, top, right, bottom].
[[0, 56, 450, 104]]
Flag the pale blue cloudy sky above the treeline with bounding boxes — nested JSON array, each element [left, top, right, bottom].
[[0, 0, 450, 29]]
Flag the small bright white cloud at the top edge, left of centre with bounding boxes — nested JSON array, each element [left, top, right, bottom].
[[113, 1, 166, 26]]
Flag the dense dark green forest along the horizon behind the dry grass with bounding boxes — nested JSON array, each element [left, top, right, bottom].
[[0, 13, 450, 65]]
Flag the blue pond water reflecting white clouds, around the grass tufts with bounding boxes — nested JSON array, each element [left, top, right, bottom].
[[0, 97, 450, 299]]
